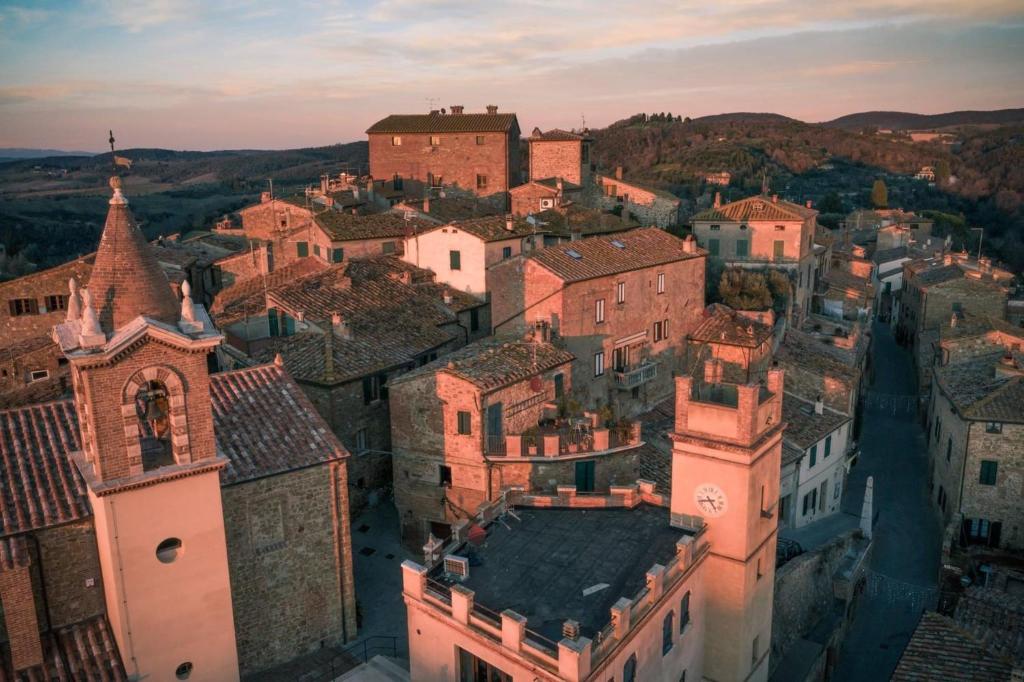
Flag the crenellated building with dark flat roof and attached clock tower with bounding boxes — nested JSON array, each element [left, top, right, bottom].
[[402, 372, 784, 682]]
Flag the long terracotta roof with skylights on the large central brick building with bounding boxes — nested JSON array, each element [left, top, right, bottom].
[[528, 227, 705, 282]]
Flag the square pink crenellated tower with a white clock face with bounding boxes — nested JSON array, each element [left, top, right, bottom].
[[672, 370, 784, 682]]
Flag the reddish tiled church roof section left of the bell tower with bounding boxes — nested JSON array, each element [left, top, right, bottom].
[[0, 399, 92, 536]]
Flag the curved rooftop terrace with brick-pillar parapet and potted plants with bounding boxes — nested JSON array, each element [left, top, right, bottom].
[[484, 418, 640, 458]]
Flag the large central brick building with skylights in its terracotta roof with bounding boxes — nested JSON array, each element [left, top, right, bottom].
[[488, 227, 705, 416]]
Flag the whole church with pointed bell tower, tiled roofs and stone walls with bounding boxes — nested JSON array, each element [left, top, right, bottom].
[[0, 178, 355, 680]]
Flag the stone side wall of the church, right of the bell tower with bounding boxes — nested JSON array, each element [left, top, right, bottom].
[[222, 465, 355, 675]]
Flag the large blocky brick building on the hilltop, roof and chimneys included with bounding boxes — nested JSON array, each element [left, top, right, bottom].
[[367, 105, 520, 197]]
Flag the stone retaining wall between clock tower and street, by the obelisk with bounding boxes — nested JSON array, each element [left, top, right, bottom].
[[771, 528, 860, 665]]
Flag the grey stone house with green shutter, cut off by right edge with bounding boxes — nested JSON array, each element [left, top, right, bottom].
[[928, 350, 1024, 550]]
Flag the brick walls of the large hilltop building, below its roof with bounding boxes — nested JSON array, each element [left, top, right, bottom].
[[369, 128, 519, 196]]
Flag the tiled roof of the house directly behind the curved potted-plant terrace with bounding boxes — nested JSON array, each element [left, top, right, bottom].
[[394, 338, 575, 390]]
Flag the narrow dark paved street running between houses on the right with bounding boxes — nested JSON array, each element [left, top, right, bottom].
[[834, 324, 940, 682]]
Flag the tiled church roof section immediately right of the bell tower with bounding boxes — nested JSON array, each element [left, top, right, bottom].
[[210, 365, 348, 485]]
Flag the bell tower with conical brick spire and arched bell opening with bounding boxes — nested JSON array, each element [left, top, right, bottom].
[[54, 177, 239, 680]]
